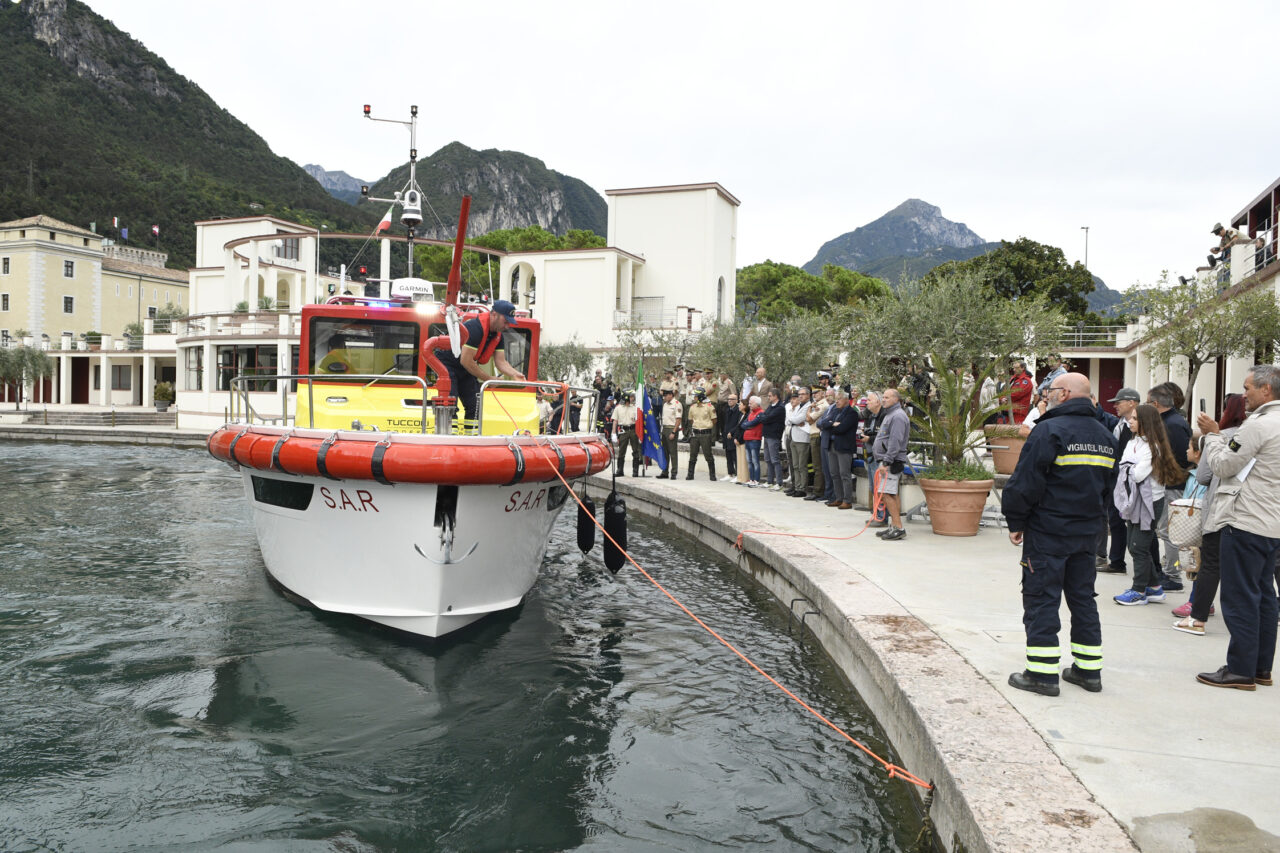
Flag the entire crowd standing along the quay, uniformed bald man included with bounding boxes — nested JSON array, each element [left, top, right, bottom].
[[583, 359, 1280, 695]]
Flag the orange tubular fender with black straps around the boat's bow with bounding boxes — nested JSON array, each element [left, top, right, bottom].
[[207, 427, 613, 485]]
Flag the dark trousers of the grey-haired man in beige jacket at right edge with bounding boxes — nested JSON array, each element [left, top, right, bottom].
[[1220, 525, 1280, 678]]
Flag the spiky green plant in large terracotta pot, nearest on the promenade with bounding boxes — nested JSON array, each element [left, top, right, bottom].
[[909, 356, 1000, 537]]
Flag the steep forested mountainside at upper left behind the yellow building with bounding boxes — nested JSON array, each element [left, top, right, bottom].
[[0, 0, 376, 266]]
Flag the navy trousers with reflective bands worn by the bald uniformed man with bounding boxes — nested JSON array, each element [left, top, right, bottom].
[[1023, 530, 1102, 684]]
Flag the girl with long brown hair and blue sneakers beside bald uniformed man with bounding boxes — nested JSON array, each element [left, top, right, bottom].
[[1115, 405, 1187, 606]]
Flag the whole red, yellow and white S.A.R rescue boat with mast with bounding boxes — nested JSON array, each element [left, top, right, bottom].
[[207, 108, 612, 638]]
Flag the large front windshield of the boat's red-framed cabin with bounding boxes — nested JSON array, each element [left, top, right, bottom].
[[310, 316, 420, 379]]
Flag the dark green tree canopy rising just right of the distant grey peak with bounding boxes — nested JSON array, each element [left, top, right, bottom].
[[920, 237, 1094, 321]]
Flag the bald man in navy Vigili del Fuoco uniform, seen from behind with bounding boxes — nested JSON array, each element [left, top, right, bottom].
[[1001, 373, 1116, 695]]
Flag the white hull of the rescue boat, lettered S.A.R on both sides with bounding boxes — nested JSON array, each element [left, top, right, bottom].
[[242, 467, 568, 637]]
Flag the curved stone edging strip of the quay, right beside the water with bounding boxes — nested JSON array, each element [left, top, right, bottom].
[[588, 476, 1137, 853]]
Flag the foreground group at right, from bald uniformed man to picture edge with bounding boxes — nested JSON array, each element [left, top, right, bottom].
[[1002, 365, 1280, 695]]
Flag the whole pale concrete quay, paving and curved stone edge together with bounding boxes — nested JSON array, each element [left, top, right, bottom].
[[589, 468, 1280, 853]]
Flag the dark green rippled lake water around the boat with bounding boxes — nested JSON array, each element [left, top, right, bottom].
[[0, 442, 919, 852]]
